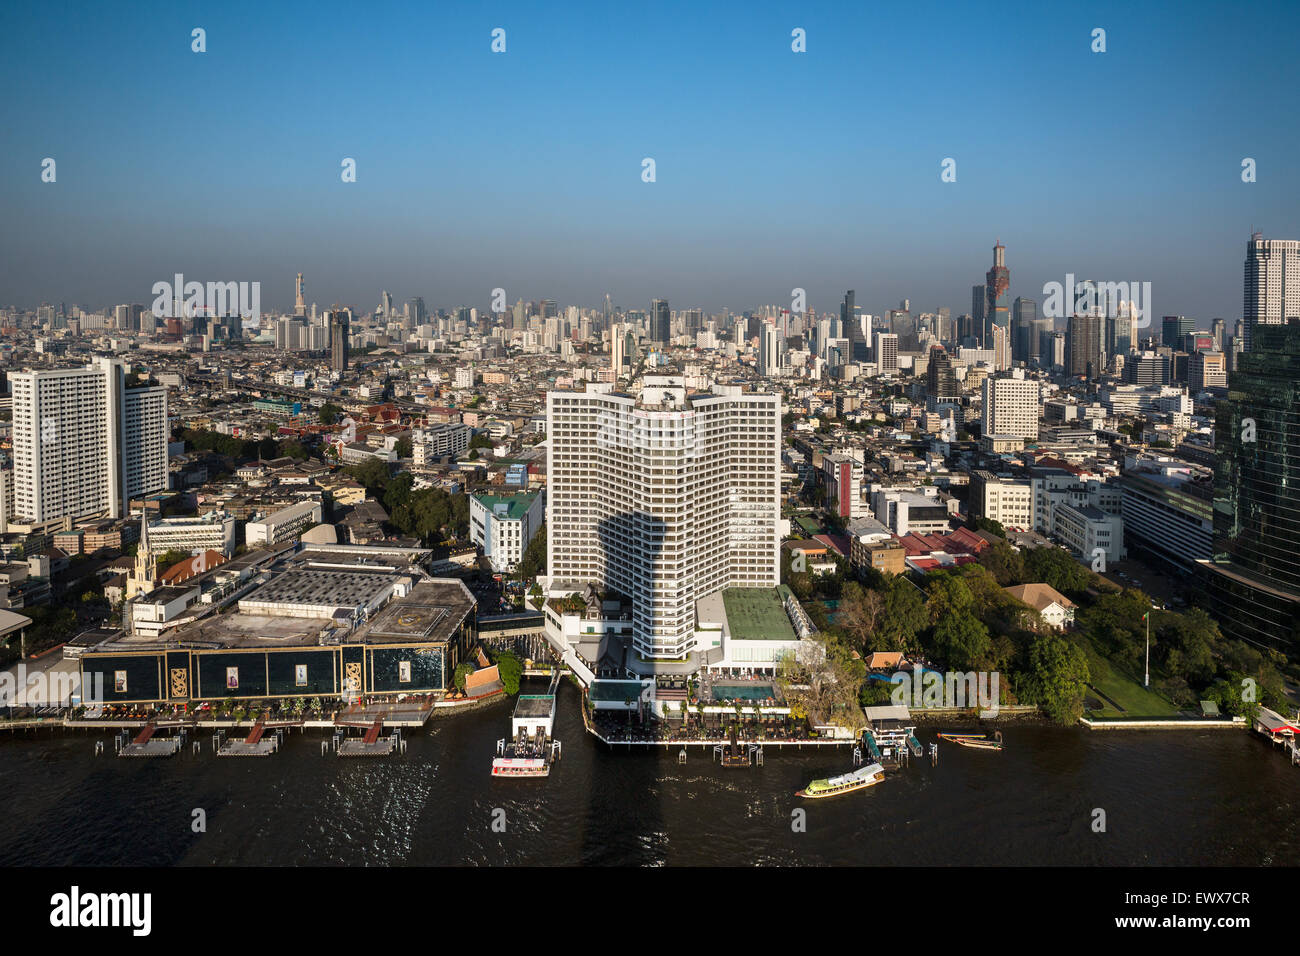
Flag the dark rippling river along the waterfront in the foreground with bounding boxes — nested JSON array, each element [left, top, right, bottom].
[[0, 683, 1300, 866]]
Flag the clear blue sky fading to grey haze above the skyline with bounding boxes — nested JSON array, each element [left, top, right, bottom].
[[0, 1, 1300, 321]]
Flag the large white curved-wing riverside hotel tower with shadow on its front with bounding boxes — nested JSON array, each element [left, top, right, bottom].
[[546, 376, 781, 661]]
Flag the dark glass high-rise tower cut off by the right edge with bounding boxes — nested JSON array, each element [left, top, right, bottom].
[[1206, 320, 1300, 656]]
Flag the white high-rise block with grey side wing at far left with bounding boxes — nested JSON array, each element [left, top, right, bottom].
[[9, 359, 168, 528]]
